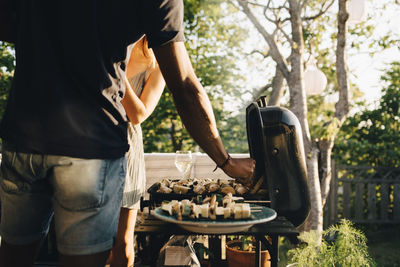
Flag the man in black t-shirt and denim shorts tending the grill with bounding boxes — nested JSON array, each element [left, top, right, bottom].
[[0, 0, 254, 267]]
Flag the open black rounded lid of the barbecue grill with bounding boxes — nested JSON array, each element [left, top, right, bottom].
[[246, 97, 310, 226]]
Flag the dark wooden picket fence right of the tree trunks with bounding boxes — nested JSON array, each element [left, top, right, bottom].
[[324, 163, 400, 227]]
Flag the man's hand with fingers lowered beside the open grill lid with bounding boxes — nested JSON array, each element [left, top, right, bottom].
[[222, 158, 256, 185]]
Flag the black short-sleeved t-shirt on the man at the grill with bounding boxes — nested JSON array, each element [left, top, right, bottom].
[[0, 0, 184, 158]]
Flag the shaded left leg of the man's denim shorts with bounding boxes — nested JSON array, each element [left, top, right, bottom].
[[0, 151, 53, 245]]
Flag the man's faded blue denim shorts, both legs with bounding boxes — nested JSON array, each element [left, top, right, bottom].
[[0, 149, 126, 255]]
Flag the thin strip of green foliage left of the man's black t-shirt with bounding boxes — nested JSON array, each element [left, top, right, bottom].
[[0, 41, 15, 118]]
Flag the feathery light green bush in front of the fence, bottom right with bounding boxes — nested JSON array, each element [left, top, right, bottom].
[[288, 219, 375, 267]]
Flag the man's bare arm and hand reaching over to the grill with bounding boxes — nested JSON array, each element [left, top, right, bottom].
[[153, 42, 254, 183]]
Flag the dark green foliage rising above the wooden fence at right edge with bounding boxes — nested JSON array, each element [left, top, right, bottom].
[[334, 62, 400, 167]]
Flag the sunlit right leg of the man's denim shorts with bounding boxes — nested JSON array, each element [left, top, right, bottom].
[[49, 157, 126, 255]]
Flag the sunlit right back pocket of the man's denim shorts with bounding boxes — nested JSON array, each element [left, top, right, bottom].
[[52, 158, 108, 211]]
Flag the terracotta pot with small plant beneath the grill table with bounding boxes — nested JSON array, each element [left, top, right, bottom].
[[225, 236, 271, 267]]
